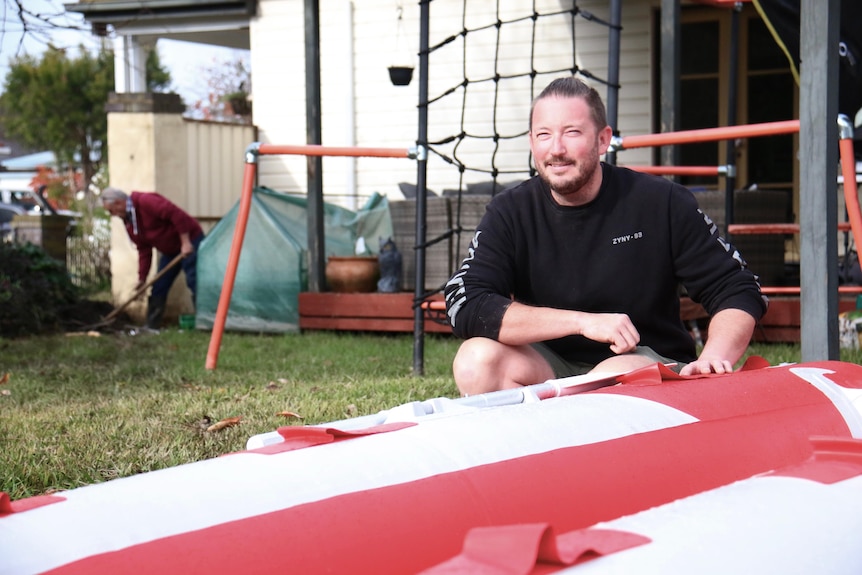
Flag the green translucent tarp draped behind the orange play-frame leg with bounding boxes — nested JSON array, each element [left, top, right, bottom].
[[195, 187, 392, 333]]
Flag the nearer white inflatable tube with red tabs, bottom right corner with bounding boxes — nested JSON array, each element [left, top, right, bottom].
[[422, 438, 862, 575]]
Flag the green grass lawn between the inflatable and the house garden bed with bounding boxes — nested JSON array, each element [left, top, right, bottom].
[[0, 329, 862, 499]]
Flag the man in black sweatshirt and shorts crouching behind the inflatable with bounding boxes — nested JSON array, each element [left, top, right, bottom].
[[444, 77, 767, 395]]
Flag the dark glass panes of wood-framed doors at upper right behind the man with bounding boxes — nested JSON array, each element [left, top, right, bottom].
[[653, 5, 799, 195]]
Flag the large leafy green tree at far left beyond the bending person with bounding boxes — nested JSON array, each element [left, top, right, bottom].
[[0, 47, 114, 205]]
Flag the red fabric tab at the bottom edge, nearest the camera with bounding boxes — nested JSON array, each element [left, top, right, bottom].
[[422, 523, 650, 575]]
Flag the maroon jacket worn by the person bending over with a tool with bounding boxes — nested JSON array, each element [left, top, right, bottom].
[[125, 192, 203, 282]]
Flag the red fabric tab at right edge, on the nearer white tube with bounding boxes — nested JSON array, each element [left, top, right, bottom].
[[773, 436, 862, 485]]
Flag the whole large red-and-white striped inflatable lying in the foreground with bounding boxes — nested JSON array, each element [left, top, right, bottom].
[[0, 362, 862, 575]]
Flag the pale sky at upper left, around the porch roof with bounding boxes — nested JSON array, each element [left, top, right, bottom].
[[0, 0, 247, 104]]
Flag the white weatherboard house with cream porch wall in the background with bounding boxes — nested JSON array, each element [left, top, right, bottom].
[[67, 0, 799, 324]]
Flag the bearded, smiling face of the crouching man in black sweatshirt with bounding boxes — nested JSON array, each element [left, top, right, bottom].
[[530, 97, 611, 200]]
